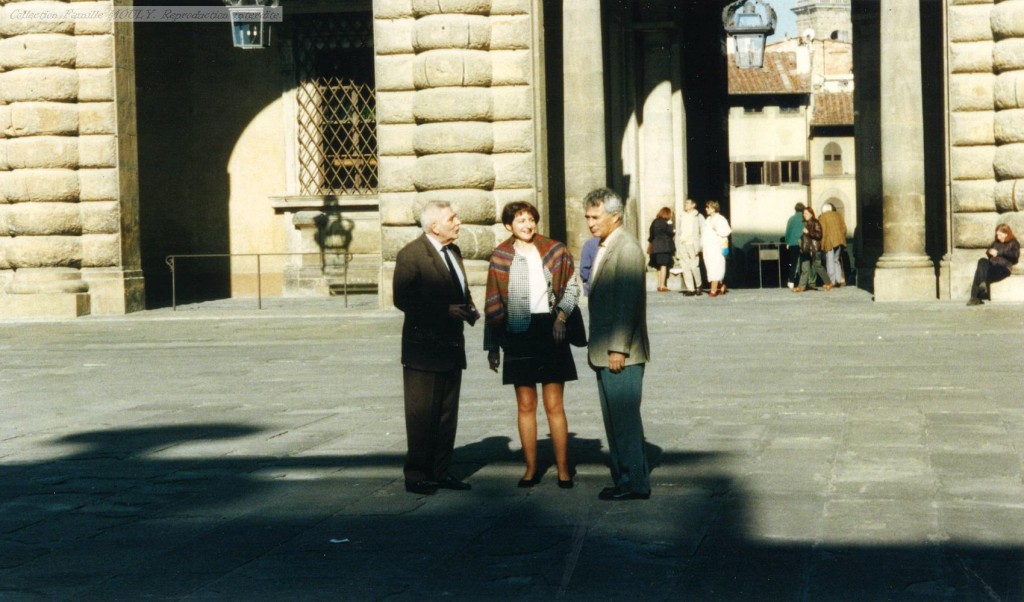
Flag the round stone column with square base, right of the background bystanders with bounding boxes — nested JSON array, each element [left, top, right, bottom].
[[874, 0, 937, 301]]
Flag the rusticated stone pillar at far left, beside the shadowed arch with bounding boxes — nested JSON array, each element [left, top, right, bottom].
[[0, 1, 143, 316]]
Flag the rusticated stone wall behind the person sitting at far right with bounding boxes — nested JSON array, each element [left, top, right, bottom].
[[947, 0, 1024, 299]]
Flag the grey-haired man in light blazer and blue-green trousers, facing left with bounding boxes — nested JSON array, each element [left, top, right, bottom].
[[584, 188, 650, 502]]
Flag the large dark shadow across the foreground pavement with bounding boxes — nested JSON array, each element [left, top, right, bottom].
[[0, 423, 1024, 600]]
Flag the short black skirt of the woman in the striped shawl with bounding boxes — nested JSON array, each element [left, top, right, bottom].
[[502, 313, 577, 385]]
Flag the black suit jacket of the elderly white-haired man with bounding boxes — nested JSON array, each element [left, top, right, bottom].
[[392, 234, 473, 372]]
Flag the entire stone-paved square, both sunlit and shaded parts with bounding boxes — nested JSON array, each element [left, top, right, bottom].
[[0, 289, 1024, 601]]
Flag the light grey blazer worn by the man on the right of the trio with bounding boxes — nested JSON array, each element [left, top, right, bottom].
[[588, 226, 650, 368]]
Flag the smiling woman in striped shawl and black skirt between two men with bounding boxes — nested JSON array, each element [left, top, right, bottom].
[[483, 202, 580, 489]]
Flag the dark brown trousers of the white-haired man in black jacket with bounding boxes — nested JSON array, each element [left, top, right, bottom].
[[402, 368, 462, 484]]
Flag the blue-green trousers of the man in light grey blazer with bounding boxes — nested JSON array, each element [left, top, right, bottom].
[[597, 363, 650, 493]]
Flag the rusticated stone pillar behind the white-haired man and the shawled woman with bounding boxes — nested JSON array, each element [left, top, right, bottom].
[[374, 0, 538, 303]]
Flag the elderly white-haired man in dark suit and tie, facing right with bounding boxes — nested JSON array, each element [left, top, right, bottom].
[[393, 202, 479, 496]]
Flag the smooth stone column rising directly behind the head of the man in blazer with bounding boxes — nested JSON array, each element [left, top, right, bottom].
[[562, 0, 606, 255]]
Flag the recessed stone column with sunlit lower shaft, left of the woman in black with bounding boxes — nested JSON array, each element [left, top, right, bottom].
[[638, 32, 680, 238]]
